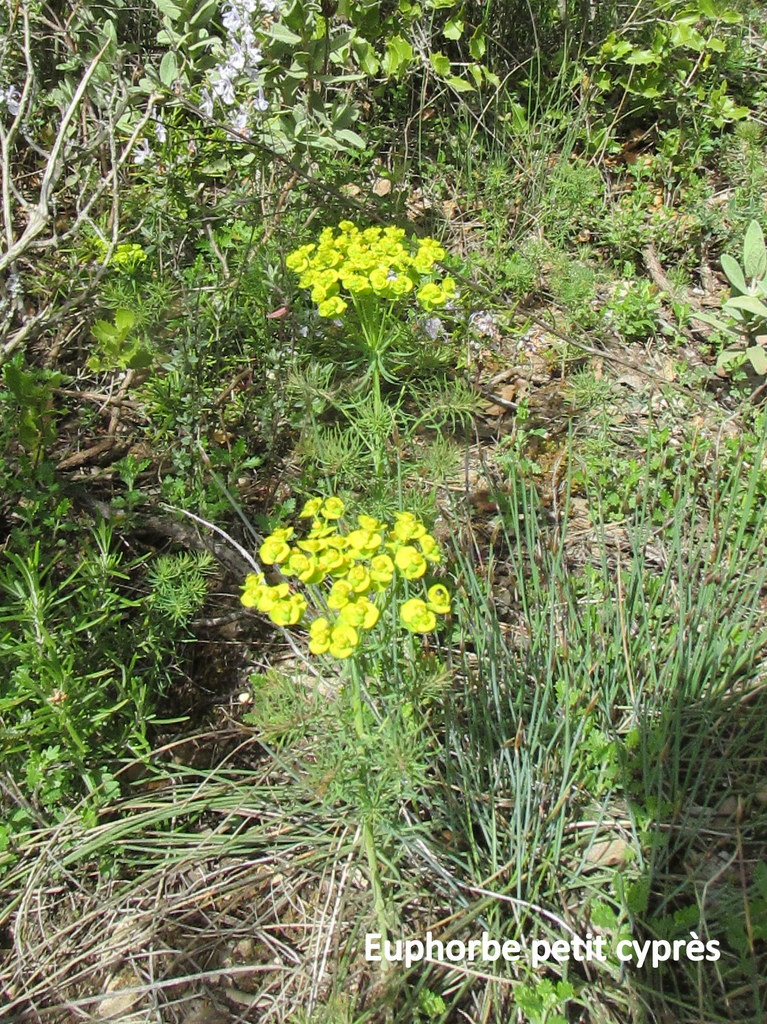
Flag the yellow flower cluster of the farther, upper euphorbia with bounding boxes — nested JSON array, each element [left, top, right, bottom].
[[286, 220, 456, 316]]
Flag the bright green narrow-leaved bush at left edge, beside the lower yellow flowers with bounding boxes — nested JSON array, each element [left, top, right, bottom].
[[0, 521, 209, 842]]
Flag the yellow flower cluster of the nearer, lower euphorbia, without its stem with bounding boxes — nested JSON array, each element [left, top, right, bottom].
[[242, 498, 451, 658]]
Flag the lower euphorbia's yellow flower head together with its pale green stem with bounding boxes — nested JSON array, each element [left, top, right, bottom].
[[242, 498, 451, 950]]
